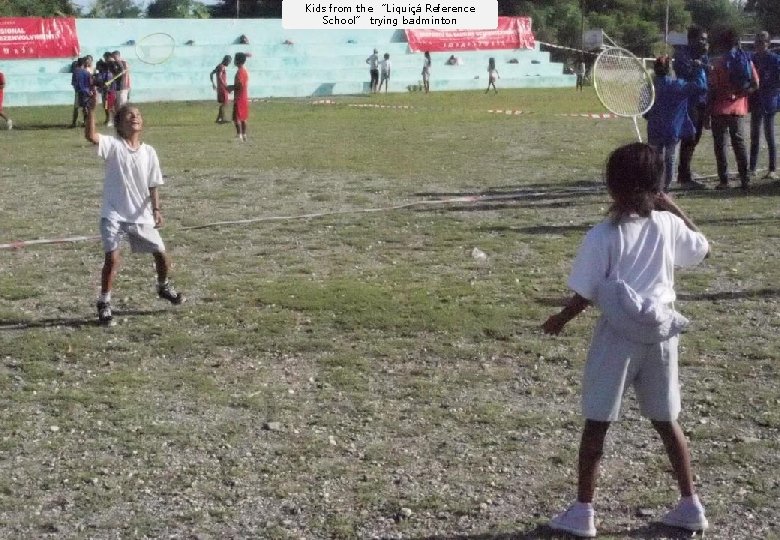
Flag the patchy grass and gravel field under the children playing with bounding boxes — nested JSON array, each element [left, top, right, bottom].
[[0, 90, 780, 540]]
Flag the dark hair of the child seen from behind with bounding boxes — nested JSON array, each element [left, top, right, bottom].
[[605, 143, 664, 224]]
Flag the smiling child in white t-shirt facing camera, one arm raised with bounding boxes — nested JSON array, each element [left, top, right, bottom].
[[84, 103, 185, 324]]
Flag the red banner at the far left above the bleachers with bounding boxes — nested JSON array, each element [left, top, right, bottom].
[[0, 17, 79, 60]]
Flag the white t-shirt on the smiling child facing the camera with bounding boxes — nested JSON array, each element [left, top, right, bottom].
[[98, 135, 164, 224]]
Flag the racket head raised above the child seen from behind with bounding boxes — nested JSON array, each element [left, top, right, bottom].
[[593, 47, 655, 118]]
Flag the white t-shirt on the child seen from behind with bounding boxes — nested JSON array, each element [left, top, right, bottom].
[[569, 211, 709, 303]]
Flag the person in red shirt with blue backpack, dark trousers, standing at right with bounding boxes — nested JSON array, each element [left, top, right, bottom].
[[709, 29, 759, 190]]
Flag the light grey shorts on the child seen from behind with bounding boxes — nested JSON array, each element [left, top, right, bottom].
[[582, 316, 680, 422]]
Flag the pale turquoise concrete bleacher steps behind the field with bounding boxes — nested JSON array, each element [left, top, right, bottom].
[[3, 19, 574, 107]]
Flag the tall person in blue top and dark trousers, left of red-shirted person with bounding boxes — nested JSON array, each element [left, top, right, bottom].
[[674, 25, 709, 189]]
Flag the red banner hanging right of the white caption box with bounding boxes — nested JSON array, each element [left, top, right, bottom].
[[406, 17, 536, 52]]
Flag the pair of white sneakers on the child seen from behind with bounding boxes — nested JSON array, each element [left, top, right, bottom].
[[550, 495, 710, 538]]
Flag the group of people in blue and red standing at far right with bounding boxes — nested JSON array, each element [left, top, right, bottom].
[[646, 25, 780, 190]]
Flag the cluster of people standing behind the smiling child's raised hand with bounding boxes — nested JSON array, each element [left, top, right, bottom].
[[70, 51, 130, 128]]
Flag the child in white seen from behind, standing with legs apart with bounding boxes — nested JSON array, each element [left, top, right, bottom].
[[542, 143, 709, 537]]
